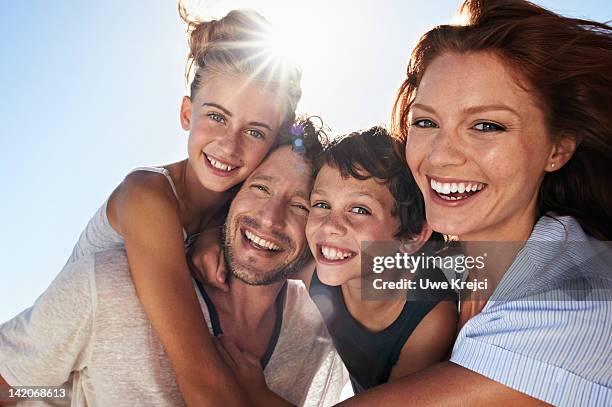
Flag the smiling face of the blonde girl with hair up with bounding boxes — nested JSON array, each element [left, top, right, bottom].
[[181, 74, 285, 192]]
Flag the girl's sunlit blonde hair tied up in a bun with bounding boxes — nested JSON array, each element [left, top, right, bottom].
[[178, 1, 302, 123]]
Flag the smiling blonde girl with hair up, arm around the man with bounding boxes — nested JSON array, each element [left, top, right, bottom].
[[69, 4, 301, 405]]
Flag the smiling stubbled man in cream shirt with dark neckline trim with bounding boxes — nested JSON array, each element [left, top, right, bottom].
[[0, 146, 347, 406]]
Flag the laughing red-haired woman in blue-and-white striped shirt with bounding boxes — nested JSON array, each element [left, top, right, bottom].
[[346, 0, 612, 406]]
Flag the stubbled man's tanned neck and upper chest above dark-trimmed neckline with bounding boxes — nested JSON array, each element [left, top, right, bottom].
[[207, 278, 286, 332]]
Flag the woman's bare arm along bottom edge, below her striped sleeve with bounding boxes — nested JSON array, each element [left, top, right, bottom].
[[338, 362, 549, 407]]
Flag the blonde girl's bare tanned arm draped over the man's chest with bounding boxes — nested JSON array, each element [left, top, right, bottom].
[[108, 172, 248, 406]]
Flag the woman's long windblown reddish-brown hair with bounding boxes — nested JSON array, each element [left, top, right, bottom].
[[391, 0, 612, 240]]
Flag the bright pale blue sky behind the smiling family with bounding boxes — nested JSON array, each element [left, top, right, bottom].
[[0, 0, 612, 323]]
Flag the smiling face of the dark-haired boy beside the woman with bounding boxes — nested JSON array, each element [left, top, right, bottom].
[[306, 165, 400, 285]]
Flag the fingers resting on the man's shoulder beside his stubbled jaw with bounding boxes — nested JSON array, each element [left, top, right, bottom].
[[189, 226, 229, 292]]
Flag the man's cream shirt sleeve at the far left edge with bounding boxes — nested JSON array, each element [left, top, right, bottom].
[[0, 256, 95, 386]]
